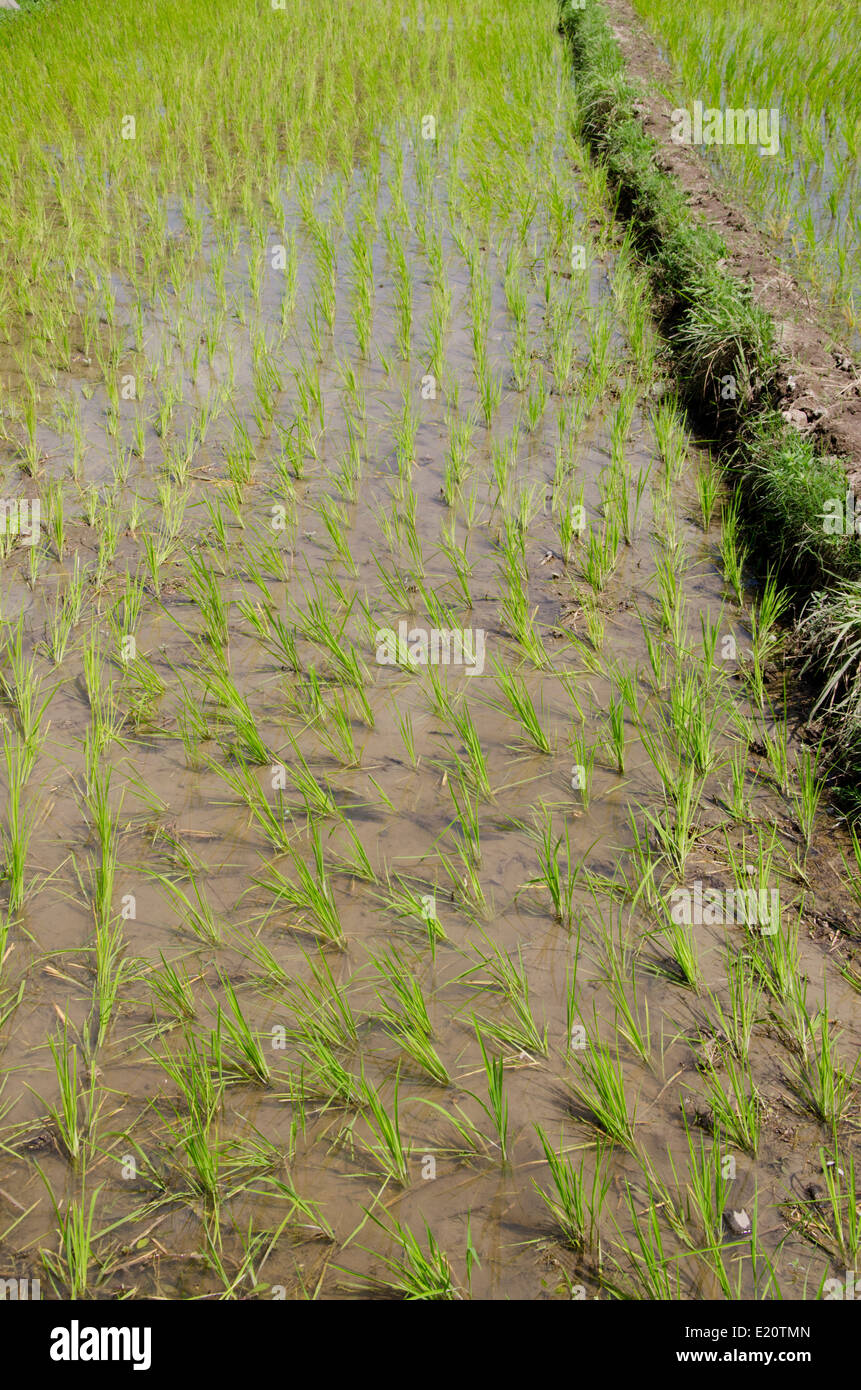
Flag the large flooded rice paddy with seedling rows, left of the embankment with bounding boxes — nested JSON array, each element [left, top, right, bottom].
[[0, 0, 861, 1301]]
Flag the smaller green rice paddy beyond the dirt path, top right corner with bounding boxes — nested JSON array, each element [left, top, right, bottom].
[[631, 0, 861, 333]]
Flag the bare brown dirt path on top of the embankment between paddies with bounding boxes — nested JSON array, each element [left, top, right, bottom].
[[604, 0, 861, 492]]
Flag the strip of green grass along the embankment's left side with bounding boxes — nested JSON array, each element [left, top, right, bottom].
[[559, 0, 861, 801]]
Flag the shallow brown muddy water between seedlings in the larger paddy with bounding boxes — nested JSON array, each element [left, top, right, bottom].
[[0, 116, 860, 1298]]
